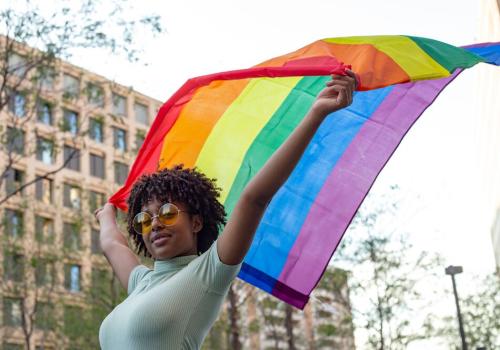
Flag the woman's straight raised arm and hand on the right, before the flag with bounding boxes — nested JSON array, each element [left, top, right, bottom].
[[217, 72, 356, 265]]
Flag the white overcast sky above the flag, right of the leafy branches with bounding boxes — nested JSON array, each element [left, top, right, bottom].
[[67, 0, 478, 100]]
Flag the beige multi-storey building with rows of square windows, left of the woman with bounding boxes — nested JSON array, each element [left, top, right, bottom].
[[0, 37, 161, 349]]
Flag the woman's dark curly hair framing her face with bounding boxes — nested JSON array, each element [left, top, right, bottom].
[[127, 164, 226, 257]]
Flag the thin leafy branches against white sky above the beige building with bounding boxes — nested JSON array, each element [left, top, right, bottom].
[[0, 0, 163, 61]]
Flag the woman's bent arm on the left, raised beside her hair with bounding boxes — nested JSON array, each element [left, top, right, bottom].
[[95, 203, 140, 290]]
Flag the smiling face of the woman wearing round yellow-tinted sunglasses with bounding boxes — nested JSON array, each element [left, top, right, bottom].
[[142, 199, 202, 260]]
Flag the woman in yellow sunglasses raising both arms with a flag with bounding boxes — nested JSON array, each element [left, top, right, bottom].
[[95, 70, 356, 350]]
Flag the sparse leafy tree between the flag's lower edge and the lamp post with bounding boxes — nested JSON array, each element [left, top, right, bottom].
[[336, 186, 440, 350]]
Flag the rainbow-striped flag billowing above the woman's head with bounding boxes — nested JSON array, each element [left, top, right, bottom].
[[110, 36, 500, 309]]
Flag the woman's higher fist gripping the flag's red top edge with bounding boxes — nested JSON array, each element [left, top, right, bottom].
[[311, 70, 357, 118]]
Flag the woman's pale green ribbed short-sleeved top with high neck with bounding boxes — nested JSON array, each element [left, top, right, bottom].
[[99, 241, 242, 350]]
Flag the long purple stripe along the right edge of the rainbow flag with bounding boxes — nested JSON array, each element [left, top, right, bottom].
[[273, 70, 461, 295]]
